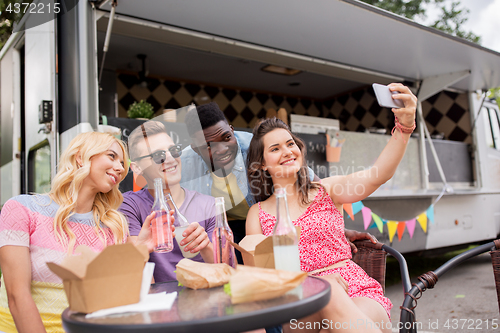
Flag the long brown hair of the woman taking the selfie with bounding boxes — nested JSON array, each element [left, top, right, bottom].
[[247, 117, 321, 204]]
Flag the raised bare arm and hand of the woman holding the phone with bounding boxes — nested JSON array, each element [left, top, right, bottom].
[[322, 83, 417, 204]]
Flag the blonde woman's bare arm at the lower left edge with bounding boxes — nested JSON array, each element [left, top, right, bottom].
[[0, 245, 45, 333]]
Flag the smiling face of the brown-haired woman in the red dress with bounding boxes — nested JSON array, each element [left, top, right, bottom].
[[262, 128, 303, 178]]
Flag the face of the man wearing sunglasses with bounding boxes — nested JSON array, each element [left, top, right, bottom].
[[131, 133, 181, 188]]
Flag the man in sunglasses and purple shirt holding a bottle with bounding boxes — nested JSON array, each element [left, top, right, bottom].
[[120, 121, 215, 282]]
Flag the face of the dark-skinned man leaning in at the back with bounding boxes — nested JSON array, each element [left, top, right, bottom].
[[192, 121, 238, 175]]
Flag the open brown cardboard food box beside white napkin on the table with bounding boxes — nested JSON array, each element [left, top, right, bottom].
[[47, 243, 149, 313]]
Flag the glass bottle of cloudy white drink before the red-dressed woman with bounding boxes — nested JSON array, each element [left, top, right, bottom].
[[273, 188, 300, 272]]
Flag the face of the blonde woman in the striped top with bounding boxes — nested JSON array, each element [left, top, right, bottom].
[[83, 142, 125, 193]]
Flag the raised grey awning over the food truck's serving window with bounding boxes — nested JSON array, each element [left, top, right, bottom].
[[98, 0, 500, 98]]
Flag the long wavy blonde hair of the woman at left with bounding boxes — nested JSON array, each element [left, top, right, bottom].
[[49, 132, 129, 252]]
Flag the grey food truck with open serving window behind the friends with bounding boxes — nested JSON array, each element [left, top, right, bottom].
[[0, 0, 500, 252]]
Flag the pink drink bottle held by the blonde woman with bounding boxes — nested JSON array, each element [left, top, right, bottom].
[[151, 178, 174, 253]]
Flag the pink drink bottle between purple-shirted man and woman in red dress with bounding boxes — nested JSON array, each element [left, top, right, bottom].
[[212, 197, 236, 268]]
